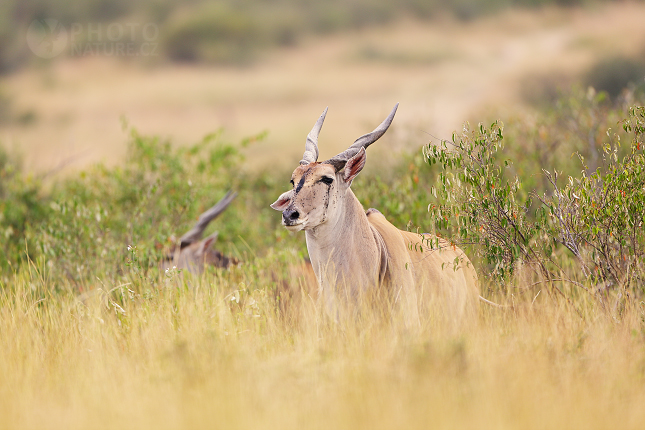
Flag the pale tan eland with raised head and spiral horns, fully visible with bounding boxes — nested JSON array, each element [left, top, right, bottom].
[[271, 104, 479, 321]]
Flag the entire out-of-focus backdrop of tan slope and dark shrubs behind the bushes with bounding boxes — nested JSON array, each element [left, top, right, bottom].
[[0, 0, 645, 172]]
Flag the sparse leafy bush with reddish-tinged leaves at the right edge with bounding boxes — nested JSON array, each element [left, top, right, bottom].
[[541, 107, 645, 294]]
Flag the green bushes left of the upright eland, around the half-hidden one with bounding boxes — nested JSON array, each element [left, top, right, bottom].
[[0, 126, 303, 287]]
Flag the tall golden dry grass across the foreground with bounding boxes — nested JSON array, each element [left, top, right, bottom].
[[0, 260, 645, 429]]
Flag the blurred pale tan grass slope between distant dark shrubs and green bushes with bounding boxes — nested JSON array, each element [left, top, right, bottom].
[[0, 2, 645, 175]]
